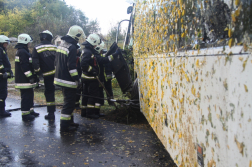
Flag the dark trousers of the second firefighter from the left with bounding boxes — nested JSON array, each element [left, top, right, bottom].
[[20, 88, 34, 112]]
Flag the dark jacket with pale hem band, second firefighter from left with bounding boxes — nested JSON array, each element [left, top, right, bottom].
[[15, 44, 37, 89]]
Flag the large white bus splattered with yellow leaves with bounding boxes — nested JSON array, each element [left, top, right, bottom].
[[119, 0, 252, 167]]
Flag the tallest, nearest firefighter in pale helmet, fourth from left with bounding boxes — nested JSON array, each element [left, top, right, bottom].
[[54, 25, 85, 132]]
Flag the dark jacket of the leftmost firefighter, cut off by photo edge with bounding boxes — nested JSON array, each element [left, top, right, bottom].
[[0, 46, 11, 80]]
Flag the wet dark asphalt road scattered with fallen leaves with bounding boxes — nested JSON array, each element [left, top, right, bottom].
[[0, 98, 176, 167]]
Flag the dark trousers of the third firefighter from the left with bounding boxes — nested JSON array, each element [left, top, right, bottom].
[[44, 75, 56, 113]]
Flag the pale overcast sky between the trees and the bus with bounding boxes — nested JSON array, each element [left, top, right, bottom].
[[65, 0, 133, 34]]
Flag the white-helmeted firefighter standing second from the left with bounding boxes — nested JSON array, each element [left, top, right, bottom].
[[15, 34, 39, 121]]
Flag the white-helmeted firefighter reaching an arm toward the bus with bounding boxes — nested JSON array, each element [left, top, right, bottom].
[[81, 34, 114, 119]]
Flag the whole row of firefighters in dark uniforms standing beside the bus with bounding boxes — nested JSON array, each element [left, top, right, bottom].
[[0, 25, 120, 132]]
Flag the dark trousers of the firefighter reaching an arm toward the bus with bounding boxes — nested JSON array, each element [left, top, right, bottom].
[[81, 79, 100, 115]]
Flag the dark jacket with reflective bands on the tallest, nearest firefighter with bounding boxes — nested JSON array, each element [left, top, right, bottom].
[[54, 36, 79, 88]]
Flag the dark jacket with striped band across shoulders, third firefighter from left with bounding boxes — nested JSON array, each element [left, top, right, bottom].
[[32, 40, 57, 77]]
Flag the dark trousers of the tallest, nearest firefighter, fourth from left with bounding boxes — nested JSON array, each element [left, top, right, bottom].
[[61, 87, 77, 117]]
